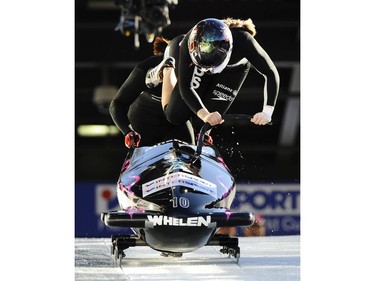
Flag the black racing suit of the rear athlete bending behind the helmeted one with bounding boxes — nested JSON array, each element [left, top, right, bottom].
[[109, 56, 194, 146]]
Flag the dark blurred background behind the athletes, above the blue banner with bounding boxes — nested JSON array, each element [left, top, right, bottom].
[[75, 0, 300, 182]]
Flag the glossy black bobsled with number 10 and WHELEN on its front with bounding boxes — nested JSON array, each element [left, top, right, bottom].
[[101, 115, 254, 264]]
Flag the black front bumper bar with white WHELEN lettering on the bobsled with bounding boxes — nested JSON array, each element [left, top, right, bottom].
[[101, 210, 255, 228]]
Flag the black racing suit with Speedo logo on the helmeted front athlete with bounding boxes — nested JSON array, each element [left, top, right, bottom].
[[164, 28, 279, 129]]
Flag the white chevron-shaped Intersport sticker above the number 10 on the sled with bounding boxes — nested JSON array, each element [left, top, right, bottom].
[[142, 172, 217, 197]]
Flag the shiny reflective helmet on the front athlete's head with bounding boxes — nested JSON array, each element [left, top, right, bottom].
[[188, 18, 233, 73]]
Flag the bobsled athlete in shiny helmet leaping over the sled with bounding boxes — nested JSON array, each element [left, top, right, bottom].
[[146, 18, 280, 128]]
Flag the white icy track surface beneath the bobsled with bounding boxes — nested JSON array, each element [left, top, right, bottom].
[[75, 236, 300, 281]]
